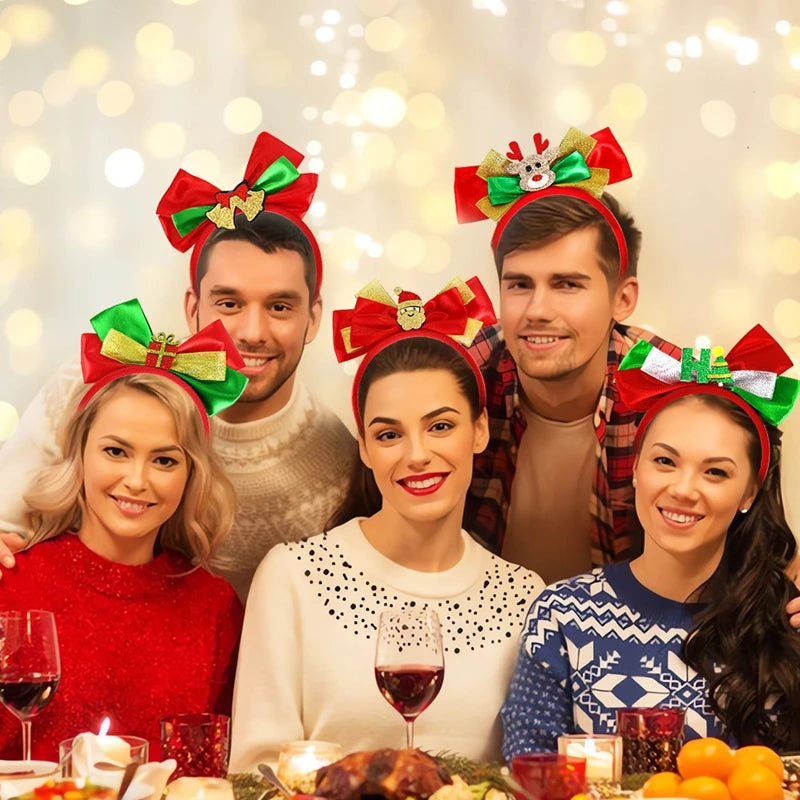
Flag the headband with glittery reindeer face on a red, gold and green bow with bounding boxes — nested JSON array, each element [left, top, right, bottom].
[[454, 128, 631, 278]]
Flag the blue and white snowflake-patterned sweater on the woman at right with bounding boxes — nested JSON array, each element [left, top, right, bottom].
[[502, 562, 721, 761]]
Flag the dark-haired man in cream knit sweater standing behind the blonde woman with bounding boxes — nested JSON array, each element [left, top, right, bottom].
[[0, 134, 357, 602]]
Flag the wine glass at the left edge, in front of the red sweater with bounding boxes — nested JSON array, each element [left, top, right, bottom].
[[0, 611, 61, 761]]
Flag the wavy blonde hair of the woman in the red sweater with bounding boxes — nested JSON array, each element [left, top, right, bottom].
[[24, 372, 236, 565]]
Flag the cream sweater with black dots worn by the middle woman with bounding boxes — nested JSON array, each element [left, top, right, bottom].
[[231, 520, 544, 772]]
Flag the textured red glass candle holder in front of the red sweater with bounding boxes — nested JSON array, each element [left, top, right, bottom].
[[161, 714, 231, 780]]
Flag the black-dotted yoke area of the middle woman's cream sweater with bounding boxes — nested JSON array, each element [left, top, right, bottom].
[[287, 534, 540, 655]]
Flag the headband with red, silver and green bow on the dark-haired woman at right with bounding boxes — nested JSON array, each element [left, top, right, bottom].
[[616, 325, 800, 483]]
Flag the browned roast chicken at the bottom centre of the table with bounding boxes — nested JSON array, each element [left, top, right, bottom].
[[314, 749, 452, 800]]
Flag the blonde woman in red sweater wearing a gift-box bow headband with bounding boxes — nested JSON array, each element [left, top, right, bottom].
[[0, 300, 245, 759]]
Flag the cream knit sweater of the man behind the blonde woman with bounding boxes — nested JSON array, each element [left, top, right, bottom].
[[0, 361, 358, 602]]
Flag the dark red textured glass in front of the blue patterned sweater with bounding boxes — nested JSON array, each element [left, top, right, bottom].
[[617, 708, 686, 775]]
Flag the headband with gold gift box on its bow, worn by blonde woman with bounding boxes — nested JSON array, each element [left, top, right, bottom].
[[78, 299, 247, 433]]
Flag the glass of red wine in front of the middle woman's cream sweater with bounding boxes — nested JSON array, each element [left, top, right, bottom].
[[375, 608, 444, 749]]
